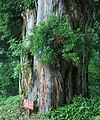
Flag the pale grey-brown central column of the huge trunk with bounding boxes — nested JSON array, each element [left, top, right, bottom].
[[35, 0, 65, 112]]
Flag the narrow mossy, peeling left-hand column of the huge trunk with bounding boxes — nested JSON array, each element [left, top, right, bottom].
[[19, 9, 36, 100]]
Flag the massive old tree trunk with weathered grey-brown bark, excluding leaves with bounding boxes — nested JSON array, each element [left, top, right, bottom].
[[19, 0, 93, 112]]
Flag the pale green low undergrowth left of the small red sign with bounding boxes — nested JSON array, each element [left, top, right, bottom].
[[0, 96, 20, 120]]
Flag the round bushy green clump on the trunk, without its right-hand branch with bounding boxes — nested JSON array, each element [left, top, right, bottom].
[[30, 16, 75, 63]]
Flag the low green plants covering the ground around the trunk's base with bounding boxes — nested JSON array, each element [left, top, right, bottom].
[[0, 86, 100, 120]]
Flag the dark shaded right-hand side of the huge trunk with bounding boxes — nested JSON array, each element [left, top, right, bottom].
[[64, 0, 93, 96]]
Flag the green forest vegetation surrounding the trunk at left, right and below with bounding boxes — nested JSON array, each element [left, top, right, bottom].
[[0, 0, 100, 120]]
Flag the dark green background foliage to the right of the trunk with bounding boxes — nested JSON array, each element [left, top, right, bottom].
[[89, 0, 100, 95]]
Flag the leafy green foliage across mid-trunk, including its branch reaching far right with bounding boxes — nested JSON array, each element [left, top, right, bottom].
[[29, 16, 99, 65]]
